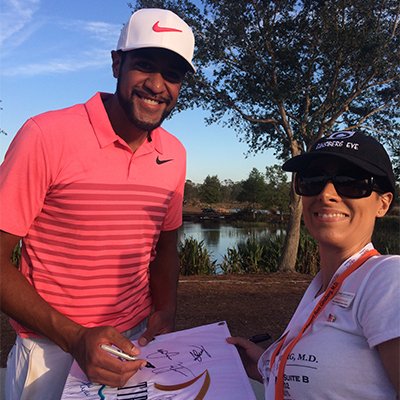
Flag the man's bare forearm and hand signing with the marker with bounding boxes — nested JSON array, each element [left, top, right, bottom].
[[0, 231, 146, 387]]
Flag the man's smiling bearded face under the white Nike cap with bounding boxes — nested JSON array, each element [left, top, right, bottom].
[[113, 48, 187, 132]]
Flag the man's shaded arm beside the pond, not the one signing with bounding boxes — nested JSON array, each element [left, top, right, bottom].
[[139, 229, 179, 346]]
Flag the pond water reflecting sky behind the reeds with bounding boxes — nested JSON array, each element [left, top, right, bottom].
[[178, 220, 286, 264]]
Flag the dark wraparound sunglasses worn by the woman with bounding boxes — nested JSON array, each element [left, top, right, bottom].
[[295, 170, 379, 199]]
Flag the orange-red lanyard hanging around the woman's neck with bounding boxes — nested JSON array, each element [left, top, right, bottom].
[[271, 249, 379, 400]]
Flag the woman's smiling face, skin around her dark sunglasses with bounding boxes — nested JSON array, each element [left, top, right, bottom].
[[302, 157, 393, 255]]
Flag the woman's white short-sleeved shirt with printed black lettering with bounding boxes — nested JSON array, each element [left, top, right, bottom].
[[258, 244, 400, 400]]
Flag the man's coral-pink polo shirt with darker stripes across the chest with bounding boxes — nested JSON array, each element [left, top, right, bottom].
[[0, 93, 186, 337]]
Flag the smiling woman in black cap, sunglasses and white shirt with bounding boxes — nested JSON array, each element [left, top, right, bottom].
[[227, 131, 400, 400]]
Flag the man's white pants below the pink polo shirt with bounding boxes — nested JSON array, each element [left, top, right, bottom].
[[5, 320, 147, 400]]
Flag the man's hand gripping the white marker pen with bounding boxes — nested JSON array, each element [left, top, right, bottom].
[[68, 326, 146, 387]]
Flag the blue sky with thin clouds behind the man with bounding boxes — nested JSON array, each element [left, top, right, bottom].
[[0, 0, 277, 183]]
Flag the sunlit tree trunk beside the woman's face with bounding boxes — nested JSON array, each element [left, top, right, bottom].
[[278, 174, 303, 272]]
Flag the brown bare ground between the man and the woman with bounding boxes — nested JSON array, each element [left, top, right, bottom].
[[0, 273, 312, 367]]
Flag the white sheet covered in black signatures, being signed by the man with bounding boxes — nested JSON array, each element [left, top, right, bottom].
[[61, 322, 256, 400]]
